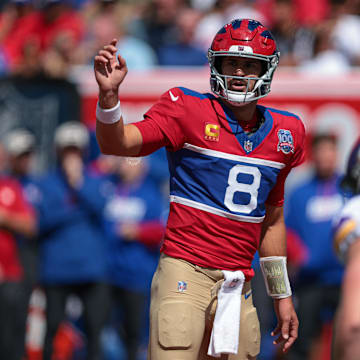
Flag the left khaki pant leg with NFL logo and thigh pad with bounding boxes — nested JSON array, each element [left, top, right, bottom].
[[148, 257, 214, 360]]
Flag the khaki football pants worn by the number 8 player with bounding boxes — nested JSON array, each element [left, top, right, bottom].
[[148, 254, 260, 360]]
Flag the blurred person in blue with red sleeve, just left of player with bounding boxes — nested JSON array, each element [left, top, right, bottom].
[[101, 157, 164, 360]]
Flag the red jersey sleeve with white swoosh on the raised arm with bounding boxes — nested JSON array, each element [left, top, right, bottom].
[[133, 88, 185, 155]]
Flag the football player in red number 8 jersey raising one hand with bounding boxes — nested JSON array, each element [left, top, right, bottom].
[[94, 19, 304, 360]]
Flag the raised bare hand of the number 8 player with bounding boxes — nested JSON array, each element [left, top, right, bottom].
[[94, 39, 128, 93]]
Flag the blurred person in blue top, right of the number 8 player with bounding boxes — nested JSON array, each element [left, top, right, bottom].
[[286, 134, 343, 360]]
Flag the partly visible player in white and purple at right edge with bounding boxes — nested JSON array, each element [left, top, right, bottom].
[[333, 139, 360, 360]]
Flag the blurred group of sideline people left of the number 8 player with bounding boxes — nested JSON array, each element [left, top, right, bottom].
[[0, 121, 167, 360]]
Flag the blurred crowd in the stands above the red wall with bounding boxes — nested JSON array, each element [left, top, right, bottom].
[[0, 0, 360, 78]]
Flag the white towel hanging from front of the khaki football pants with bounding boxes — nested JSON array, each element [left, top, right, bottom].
[[208, 270, 245, 357]]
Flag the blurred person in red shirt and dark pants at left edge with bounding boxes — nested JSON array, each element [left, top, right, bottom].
[[0, 141, 36, 360]]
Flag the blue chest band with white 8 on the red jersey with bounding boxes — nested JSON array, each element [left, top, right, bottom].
[[168, 148, 280, 218]]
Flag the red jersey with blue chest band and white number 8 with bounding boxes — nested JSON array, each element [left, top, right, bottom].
[[135, 88, 305, 280]]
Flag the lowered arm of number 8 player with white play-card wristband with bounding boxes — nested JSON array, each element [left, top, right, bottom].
[[259, 205, 299, 352]]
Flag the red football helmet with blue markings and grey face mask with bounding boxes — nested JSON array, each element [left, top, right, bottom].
[[208, 19, 280, 105]]
